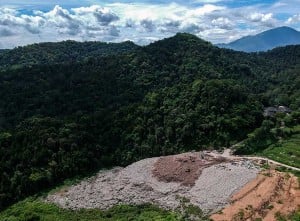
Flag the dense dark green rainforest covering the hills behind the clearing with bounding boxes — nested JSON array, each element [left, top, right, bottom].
[[0, 33, 300, 210]]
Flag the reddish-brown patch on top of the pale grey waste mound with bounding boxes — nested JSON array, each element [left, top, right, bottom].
[[152, 153, 225, 186]]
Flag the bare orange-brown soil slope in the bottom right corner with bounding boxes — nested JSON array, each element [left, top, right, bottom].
[[211, 170, 300, 221]]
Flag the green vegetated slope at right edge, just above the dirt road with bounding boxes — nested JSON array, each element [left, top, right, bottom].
[[237, 112, 300, 168]]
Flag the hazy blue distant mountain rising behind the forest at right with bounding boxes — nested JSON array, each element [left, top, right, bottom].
[[217, 26, 300, 52]]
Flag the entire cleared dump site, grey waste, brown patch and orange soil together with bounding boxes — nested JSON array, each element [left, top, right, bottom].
[[46, 149, 300, 221]]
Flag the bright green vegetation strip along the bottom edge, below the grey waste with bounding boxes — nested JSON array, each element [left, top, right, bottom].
[[0, 199, 182, 221]]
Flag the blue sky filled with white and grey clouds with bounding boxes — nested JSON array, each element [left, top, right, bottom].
[[0, 0, 300, 48]]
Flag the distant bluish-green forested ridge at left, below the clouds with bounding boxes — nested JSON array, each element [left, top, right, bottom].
[[0, 40, 139, 68]]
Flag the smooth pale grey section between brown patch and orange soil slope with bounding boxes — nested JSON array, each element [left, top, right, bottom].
[[188, 161, 259, 210]]
